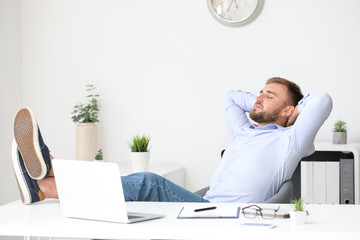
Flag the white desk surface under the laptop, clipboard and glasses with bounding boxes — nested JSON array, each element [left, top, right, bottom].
[[0, 200, 360, 240]]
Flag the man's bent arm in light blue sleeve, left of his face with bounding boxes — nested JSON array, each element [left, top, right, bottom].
[[225, 90, 256, 134]]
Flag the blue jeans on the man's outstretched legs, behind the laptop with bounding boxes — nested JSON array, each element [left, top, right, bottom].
[[121, 172, 209, 202]]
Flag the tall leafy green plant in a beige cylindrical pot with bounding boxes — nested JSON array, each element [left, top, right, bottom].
[[71, 84, 99, 160]]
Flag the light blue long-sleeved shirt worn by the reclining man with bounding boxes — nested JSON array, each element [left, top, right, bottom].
[[205, 90, 332, 203]]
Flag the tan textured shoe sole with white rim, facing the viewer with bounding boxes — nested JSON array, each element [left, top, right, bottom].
[[14, 108, 47, 180]]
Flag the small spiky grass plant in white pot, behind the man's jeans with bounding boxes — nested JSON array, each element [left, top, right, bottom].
[[129, 135, 150, 172]]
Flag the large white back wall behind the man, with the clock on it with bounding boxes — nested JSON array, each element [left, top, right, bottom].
[[1, 0, 360, 204]]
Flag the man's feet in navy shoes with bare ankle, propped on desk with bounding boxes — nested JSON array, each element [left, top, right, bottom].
[[12, 108, 58, 204]]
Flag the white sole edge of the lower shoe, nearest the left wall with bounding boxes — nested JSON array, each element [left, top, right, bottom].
[[11, 140, 32, 204]]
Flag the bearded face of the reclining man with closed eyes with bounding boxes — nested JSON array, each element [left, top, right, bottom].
[[250, 83, 289, 125]]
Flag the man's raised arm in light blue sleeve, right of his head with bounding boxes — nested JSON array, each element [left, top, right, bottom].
[[288, 93, 332, 154]]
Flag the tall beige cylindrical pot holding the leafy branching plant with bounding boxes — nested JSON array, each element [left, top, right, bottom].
[[76, 123, 98, 160]]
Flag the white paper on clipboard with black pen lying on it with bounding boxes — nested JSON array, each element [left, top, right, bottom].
[[178, 205, 240, 219]]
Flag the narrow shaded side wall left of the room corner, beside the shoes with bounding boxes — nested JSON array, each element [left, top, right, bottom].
[[0, 0, 22, 205]]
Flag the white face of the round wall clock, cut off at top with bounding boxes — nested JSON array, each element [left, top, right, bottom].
[[208, 0, 258, 24]]
